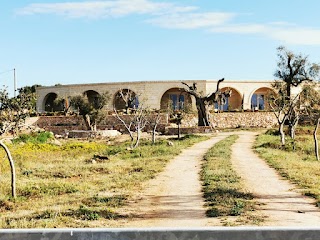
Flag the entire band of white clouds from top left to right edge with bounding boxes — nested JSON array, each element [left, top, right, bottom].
[[17, 0, 320, 45]]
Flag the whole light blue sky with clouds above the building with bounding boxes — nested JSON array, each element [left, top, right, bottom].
[[0, 0, 320, 95]]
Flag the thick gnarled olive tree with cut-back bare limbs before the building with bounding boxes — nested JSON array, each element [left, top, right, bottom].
[[182, 78, 231, 126]]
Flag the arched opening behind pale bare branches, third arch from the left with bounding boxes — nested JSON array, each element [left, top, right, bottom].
[[113, 89, 139, 111]]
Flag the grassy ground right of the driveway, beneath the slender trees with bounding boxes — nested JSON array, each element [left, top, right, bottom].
[[255, 129, 320, 207]]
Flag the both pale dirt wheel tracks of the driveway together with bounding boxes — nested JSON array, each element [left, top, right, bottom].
[[119, 132, 320, 227]]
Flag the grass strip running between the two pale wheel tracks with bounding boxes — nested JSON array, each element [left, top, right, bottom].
[[201, 135, 263, 226]]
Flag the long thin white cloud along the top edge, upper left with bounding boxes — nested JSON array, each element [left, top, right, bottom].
[[17, 0, 196, 18]]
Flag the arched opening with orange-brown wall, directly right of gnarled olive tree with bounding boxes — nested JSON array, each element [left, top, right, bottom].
[[215, 87, 243, 111]]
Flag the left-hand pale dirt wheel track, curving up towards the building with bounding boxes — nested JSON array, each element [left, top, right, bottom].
[[121, 135, 226, 227]]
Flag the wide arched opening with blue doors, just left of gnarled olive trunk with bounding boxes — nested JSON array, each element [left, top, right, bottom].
[[160, 88, 192, 111]]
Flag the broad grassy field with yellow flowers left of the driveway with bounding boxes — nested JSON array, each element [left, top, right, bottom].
[[0, 132, 207, 228]]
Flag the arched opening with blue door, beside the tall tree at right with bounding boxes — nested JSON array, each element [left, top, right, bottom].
[[251, 87, 274, 111]]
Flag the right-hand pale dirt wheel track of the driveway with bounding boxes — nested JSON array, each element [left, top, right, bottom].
[[232, 132, 320, 226]]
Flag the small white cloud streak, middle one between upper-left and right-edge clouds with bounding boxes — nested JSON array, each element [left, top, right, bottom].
[[148, 12, 234, 29]]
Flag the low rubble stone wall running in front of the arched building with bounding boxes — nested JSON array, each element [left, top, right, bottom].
[[36, 112, 277, 134]]
